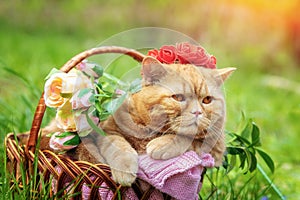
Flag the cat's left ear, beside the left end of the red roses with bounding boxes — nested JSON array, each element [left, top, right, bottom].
[[141, 56, 167, 84]]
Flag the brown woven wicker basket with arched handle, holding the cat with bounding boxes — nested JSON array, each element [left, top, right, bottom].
[[5, 46, 203, 199]]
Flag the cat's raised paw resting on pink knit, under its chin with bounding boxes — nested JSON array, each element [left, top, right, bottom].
[[146, 138, 181, 160]]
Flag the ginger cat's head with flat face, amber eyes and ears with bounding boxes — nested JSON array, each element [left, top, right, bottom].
[[133, 57, 235, 138]]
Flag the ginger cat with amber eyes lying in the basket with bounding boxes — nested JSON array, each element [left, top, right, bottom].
[[22, 57, 235, 186]]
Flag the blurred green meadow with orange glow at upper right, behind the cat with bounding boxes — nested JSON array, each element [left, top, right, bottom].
[[0, 0, 300, 199]]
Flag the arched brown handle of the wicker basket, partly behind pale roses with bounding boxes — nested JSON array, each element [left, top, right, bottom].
[[25, 46, 145, 155]]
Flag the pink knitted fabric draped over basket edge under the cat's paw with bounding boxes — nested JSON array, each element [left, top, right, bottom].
[[138, 151, 214, 200]]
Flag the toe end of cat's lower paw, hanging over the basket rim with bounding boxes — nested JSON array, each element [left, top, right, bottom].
[[111, 169, 136, 187]]
